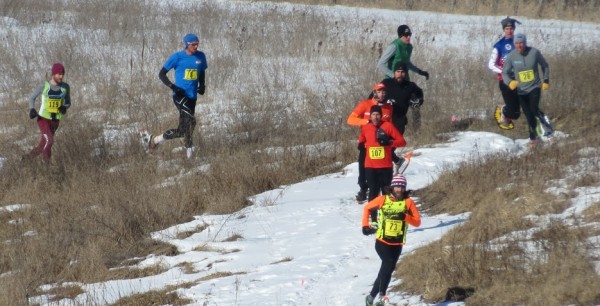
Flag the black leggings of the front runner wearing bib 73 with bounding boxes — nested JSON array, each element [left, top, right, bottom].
[[371, 240, 402, 297]]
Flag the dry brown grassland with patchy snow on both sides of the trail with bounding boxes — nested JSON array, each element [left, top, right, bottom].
[[0, 0, 600, 305]]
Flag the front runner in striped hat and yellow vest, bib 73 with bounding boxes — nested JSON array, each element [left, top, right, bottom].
[[362, 174, 421, 305]]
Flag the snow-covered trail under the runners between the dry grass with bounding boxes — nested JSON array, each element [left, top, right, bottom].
[[38, 132, 527, 306]]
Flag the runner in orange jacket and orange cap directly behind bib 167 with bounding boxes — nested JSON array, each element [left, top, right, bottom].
[[346, 83, 393, 202]]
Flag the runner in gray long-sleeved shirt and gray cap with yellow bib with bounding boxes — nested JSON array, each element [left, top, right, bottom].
[[502, 34, 550, 147]]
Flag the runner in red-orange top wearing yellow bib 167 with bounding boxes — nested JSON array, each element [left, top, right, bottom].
[[358, 105, 406, 201]]
